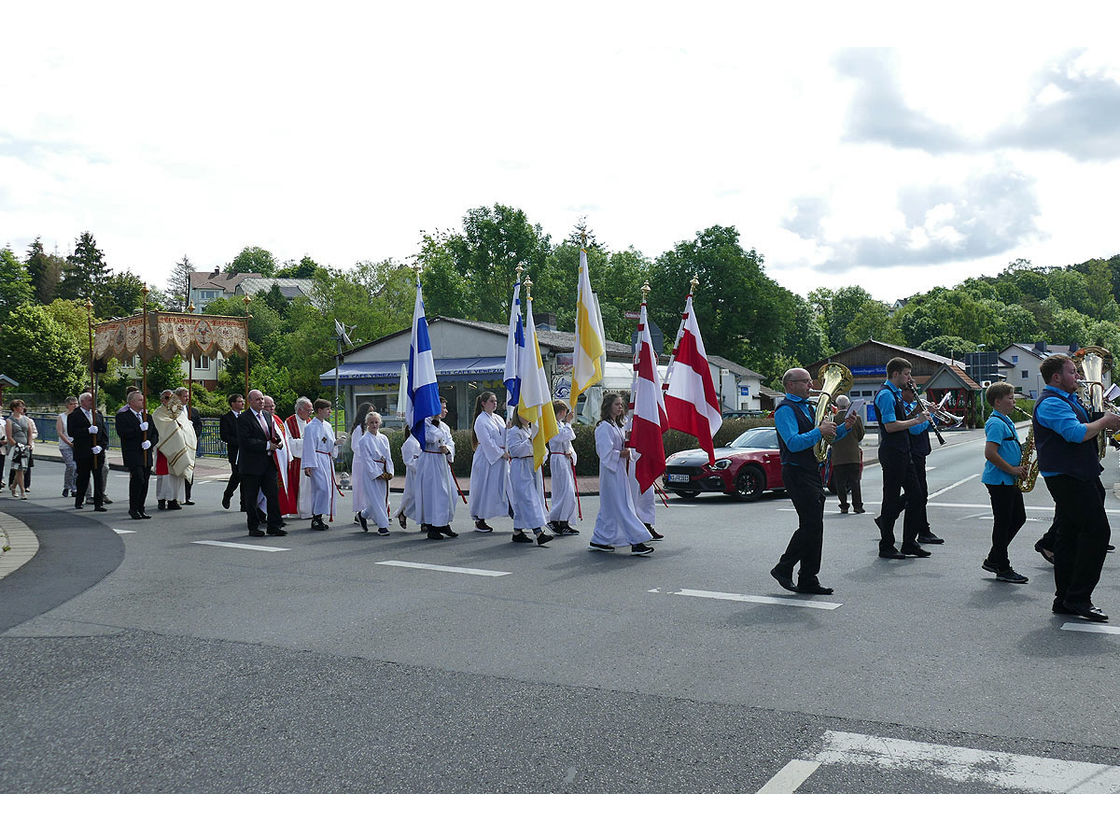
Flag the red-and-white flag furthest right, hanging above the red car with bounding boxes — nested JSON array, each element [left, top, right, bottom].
[[665, 293, 724, 464]]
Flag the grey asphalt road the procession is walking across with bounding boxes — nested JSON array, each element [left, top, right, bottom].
[[0, 432, 1120, 793]]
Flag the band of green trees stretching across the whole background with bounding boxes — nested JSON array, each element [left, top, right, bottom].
[[0, 204, 1120, 413]]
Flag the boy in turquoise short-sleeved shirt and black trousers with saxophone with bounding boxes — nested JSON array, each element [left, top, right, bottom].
[[980, 382, 1027, 584]]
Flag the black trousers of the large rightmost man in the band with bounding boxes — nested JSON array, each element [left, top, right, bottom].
[[1046, 475, 1112, 607]]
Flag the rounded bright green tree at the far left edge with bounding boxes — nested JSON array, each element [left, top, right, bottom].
[[0, 304, 84, 396]]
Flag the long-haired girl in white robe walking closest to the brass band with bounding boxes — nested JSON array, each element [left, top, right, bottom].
[[591, 393, 653, 554]]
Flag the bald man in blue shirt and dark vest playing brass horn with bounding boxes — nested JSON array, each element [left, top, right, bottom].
[[771, 367, 853, 595]]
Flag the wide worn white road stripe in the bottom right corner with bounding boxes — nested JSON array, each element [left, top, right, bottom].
[[805, 731, 1120, 793]]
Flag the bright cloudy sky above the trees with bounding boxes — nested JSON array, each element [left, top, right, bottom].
[[0, 0, 1120, 301]]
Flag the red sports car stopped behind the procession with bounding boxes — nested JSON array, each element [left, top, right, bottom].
[[664, 426, 864, 502]]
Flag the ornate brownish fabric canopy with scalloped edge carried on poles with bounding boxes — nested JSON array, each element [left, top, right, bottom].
[[93, 312, 249, 362]]
